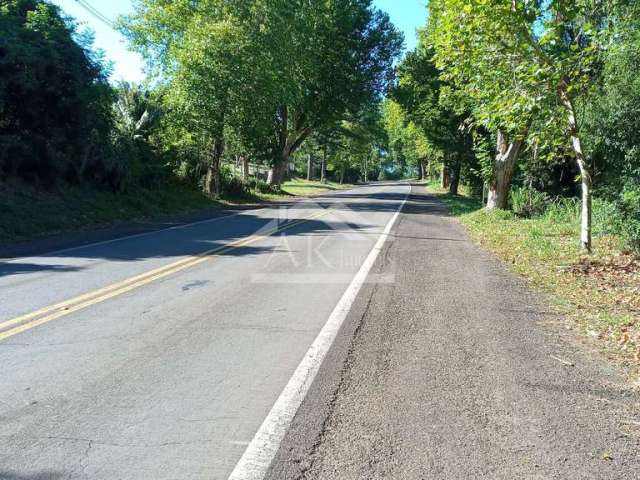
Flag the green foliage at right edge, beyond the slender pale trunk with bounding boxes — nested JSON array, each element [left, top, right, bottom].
[[578, 2, 640, 252]]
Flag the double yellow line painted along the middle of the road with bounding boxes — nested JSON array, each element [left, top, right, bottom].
[[0, 210, 329, 341]]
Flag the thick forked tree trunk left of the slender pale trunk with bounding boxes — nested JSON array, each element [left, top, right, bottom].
[[487, 130, 524, 210]]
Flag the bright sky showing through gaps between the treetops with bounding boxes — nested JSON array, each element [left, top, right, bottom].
[[49, 0, 427, 83]]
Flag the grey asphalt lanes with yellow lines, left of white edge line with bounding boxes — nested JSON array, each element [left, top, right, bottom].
[[0, 185, 410, 480]]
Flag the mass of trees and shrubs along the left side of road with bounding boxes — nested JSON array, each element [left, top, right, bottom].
[[0, 0, 402, 215]]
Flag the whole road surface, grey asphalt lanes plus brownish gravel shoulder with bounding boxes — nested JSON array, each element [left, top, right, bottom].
[[0, 184, 640, 480]]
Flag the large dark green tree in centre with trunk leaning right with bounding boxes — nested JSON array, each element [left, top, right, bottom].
[[260, 0, 402, 185]]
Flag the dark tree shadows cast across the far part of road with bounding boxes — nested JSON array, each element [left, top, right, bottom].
[[0, 187, 448, 278]]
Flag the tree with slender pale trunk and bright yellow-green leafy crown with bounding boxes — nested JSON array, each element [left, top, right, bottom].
[[432, 0, 616, 251]]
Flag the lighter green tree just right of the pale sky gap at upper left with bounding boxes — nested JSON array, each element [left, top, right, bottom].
[[122, 0, 274, 197]]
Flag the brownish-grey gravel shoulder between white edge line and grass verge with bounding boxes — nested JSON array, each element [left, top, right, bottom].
[[270, 187, 640, 480]]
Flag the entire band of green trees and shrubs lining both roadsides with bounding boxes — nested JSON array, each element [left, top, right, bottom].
[[0, 0, 640, 258]]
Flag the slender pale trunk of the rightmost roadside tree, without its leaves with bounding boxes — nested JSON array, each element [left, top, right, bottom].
[[559, 84, 593, 253]]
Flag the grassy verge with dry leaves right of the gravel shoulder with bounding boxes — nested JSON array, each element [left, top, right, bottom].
[[427, 184, 640, 375]]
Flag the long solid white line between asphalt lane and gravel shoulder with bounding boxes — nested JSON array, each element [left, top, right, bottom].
[[228, 186, 411, 480]]
